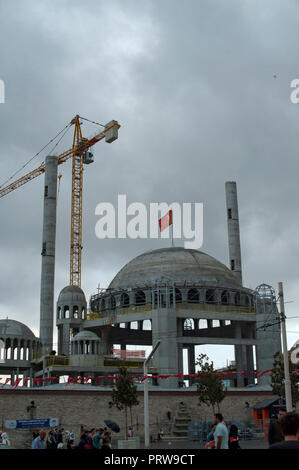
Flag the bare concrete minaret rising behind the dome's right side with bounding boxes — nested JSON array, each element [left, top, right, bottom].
[[225, 181, 242, 284]]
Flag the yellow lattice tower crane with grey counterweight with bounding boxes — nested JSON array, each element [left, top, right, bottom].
[[0, 115, 120, 287]]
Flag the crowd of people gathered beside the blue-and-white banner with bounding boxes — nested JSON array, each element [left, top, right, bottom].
[[31, 428, 111, 450]]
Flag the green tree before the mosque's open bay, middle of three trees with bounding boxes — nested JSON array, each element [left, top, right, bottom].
[[196, 354, 226, 413]]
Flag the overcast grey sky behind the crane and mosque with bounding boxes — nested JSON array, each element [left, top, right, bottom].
[[0, 0, 299, 366]]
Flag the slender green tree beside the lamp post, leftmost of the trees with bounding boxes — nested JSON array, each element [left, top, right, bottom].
[[111, 362, 139, 439]]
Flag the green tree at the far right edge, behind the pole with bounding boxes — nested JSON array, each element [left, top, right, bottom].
[[271, 352, 299, 407]]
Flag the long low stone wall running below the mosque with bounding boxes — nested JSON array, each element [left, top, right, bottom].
[[0, 389, 273, 448]]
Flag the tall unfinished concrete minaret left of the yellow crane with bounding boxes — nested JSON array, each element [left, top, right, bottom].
[[39, 156, 57, 353]]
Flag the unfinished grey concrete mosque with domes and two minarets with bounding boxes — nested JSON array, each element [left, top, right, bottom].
[[0, 156, 281, 389]]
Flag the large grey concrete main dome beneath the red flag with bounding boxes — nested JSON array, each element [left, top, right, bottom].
[[109, 247, 241, 289]]
